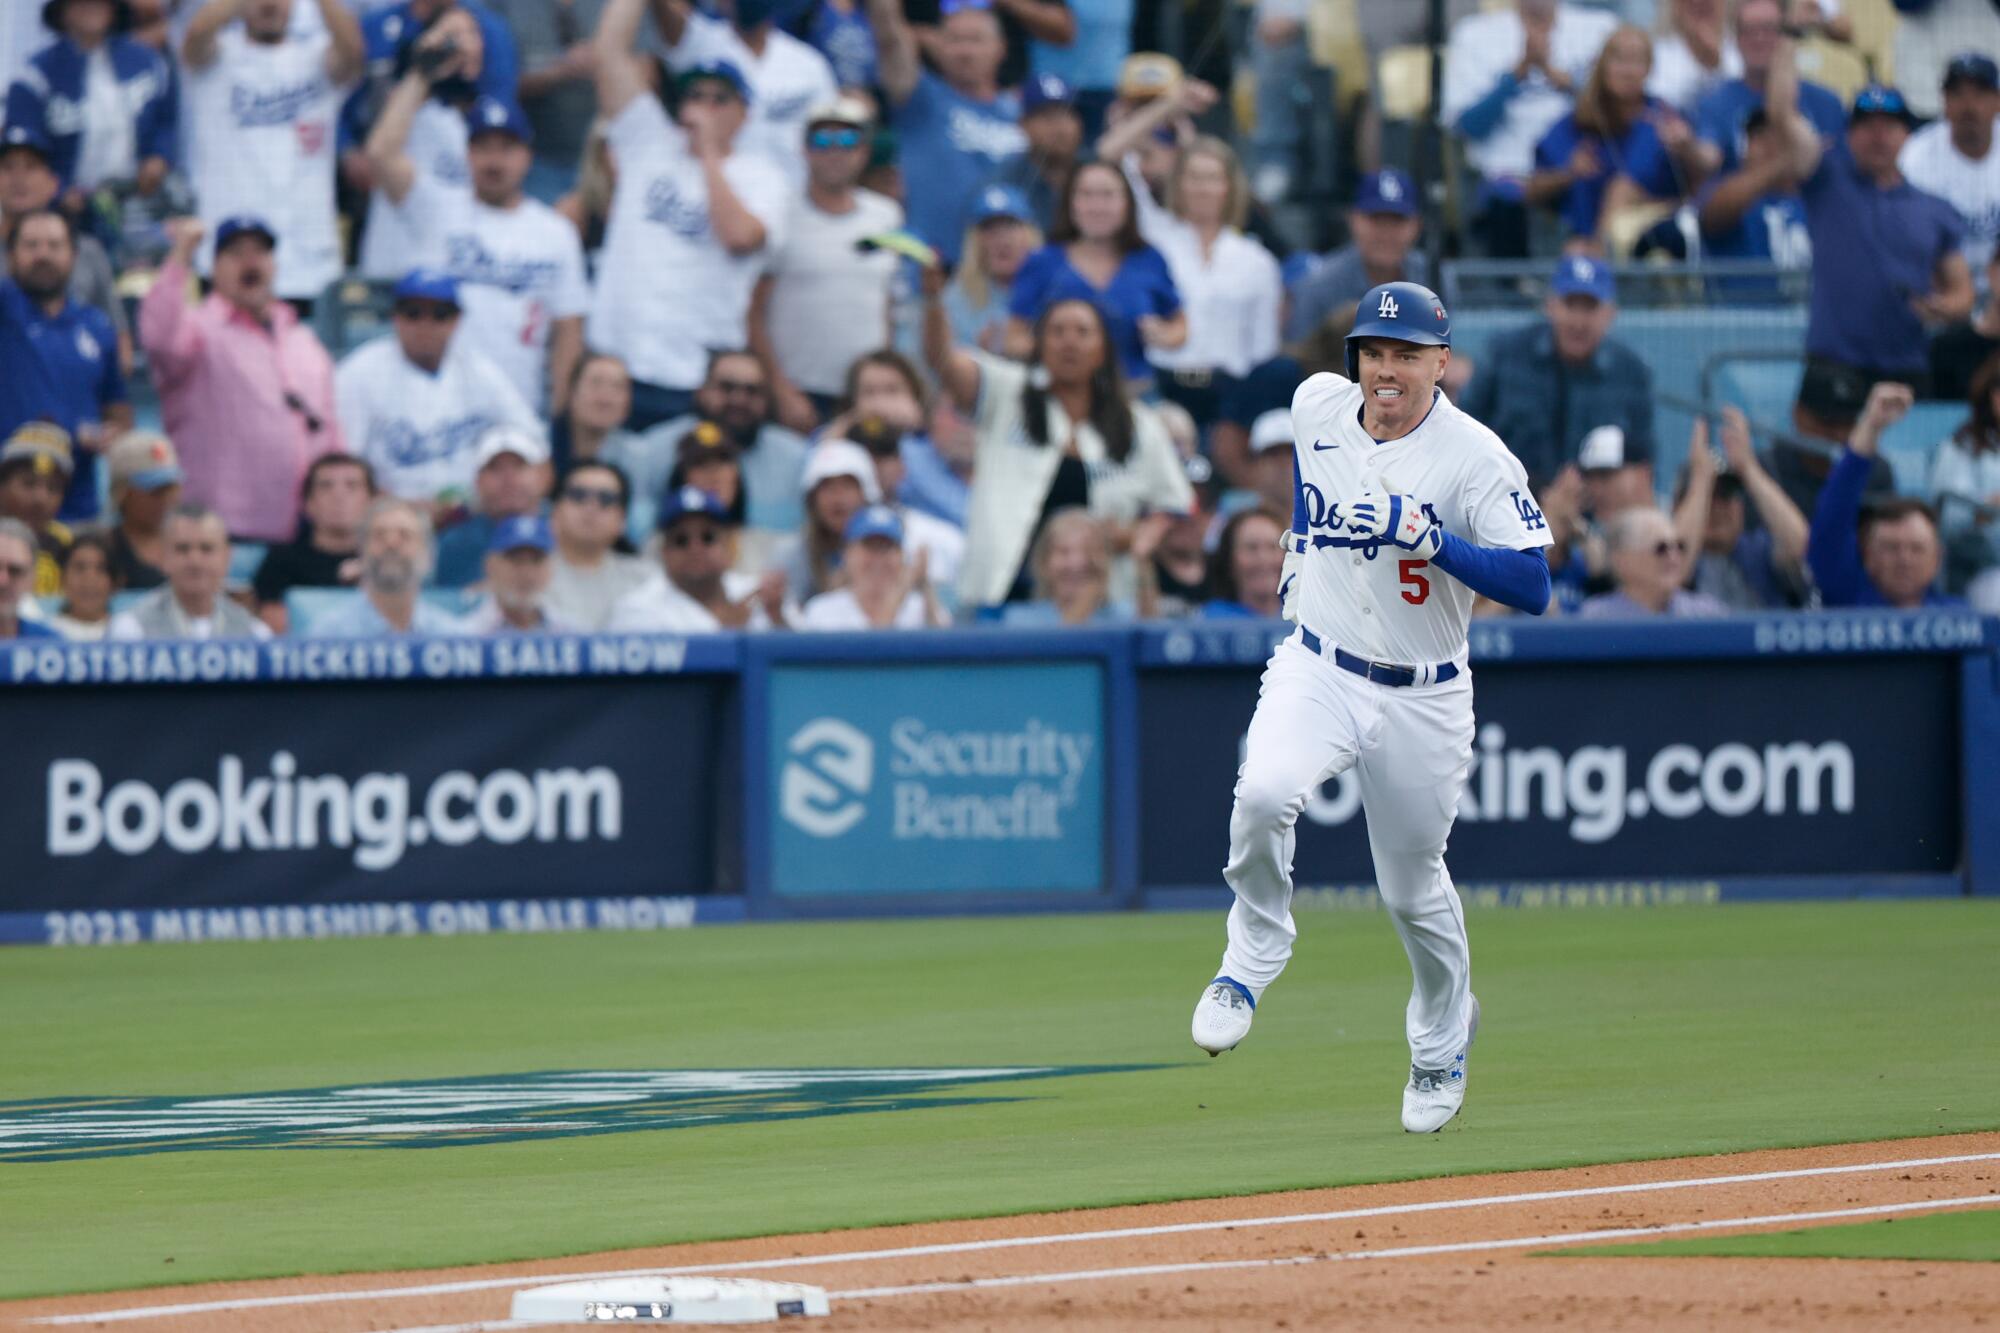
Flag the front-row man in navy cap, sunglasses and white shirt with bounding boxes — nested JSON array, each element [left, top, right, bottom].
[[610, 486, 784, 634]]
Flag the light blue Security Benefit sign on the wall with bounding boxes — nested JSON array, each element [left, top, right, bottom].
[[768, 662, 1104, 897]]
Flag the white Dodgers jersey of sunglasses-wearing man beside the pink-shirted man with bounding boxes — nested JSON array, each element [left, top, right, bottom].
[[334, 326, 542, 504]]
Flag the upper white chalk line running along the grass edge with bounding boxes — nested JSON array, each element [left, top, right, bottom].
[[30, 1153, 2000, 1325]]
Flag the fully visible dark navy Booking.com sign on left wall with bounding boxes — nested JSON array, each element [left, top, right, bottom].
[[0, 679, 724, 911]]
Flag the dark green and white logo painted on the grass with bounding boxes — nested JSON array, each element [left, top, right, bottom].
[[0, 1065, 1158, 1163]]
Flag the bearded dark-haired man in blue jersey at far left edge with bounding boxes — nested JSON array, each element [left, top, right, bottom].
[[0, 208, 132, 522]]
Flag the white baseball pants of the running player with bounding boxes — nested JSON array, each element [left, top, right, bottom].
[[1220, 634, 1472, 1069]]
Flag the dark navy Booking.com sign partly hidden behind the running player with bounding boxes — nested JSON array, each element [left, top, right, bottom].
[[1140, 656, 1960, 889]]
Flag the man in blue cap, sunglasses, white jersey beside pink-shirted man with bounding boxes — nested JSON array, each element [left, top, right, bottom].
[[334, 268, 542, 512]]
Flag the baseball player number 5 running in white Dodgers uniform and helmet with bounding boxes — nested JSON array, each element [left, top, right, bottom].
[[1194, 282, 1550, 1133]]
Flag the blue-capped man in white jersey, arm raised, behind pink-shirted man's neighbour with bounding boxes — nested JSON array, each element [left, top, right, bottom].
[[368, 89, 590, 412]]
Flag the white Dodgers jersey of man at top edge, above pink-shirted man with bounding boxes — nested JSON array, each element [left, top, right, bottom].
[[184, 22, 346, 300]]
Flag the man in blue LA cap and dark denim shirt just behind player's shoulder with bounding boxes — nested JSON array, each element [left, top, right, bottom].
[[1458, 254, 1654, 480]]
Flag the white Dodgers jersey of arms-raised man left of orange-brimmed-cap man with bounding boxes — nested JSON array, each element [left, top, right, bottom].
[[588, 96, 792, 390]]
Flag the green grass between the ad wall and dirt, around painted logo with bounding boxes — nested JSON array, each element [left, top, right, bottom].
[[0, 901, 2000, 1297]]
